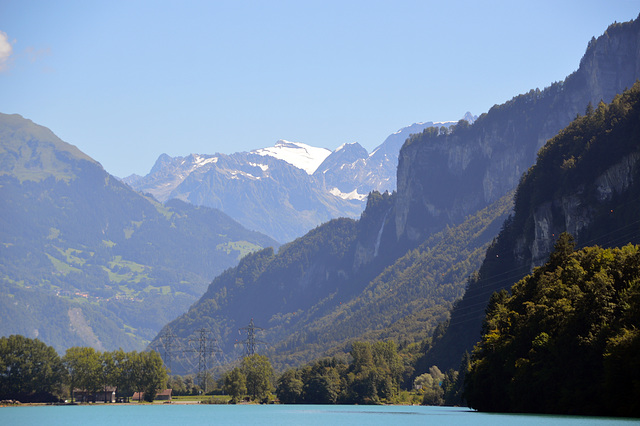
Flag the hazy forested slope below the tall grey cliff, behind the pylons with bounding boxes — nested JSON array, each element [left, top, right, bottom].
[[152, 192, 511, 371]]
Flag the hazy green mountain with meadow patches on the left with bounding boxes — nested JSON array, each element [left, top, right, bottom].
[[0, 114, 277, 350]]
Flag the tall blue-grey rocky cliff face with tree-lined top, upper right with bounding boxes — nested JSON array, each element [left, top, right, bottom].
[[395, 15, 640, 246]]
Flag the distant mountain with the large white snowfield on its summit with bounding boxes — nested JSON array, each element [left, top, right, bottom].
[[125, 141, 362, 245]]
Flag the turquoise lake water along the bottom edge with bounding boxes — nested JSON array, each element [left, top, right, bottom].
[[0, 404, 640, 426]]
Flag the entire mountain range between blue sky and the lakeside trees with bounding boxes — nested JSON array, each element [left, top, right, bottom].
[[0, 12, 640, 380]]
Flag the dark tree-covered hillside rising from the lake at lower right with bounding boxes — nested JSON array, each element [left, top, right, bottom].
[[465, 236, 640, 417]]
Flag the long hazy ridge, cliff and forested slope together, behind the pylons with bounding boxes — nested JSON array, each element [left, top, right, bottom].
[[153, 13, 640, 368]]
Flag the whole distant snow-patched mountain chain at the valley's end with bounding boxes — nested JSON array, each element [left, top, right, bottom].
[[123, 117, 474, 242]]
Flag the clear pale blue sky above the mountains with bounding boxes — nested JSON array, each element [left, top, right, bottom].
[[0, 0, 640, 177]]
